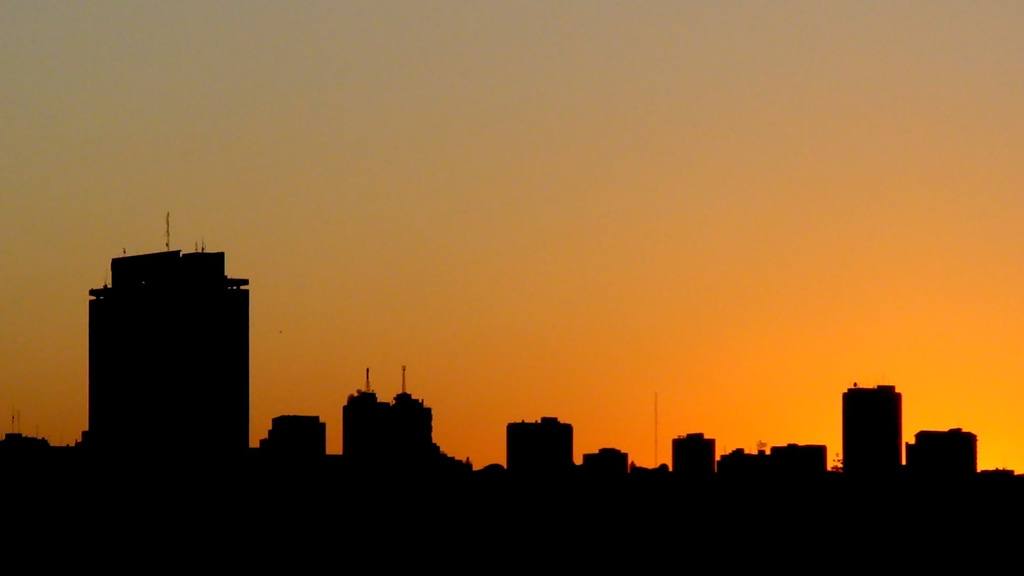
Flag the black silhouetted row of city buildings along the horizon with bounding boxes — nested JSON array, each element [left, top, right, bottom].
[[0, 243, 999, 483]]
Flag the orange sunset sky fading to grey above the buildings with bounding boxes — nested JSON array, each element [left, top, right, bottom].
[[0, 0, 1024, 470]]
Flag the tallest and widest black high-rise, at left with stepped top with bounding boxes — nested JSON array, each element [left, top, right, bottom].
[[87, 250, 249, 456]]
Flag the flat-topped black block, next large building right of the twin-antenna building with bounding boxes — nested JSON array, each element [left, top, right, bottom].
[[505, 416, 573, 475]]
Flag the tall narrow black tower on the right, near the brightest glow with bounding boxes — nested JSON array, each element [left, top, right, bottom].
[[843, 384, 903, 478]]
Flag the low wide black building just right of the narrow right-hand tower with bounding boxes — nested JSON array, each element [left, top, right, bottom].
[[906, 428, 978, 480]]
